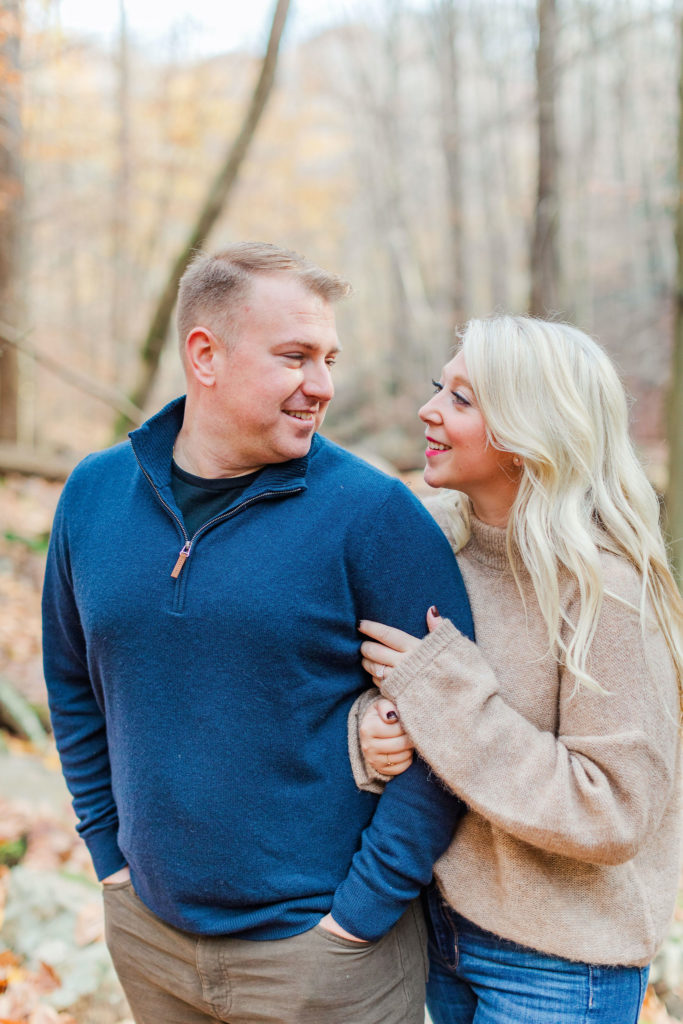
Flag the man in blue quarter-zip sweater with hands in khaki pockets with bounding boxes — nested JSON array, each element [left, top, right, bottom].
[[43, 244, 472, 1024]]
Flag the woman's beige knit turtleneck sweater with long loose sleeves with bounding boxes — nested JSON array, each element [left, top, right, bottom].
[[349, 507, 680, 965]]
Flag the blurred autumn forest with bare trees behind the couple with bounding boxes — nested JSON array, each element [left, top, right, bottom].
[[0, 0, 683, 1024]]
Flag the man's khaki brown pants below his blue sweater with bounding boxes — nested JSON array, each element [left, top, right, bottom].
[[103, 882, 427, 1024]]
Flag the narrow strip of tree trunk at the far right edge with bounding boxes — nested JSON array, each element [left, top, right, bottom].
[[667, 17, 683, 586]]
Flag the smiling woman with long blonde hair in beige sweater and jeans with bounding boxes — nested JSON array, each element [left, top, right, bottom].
[[351, 316, 683, 1024]]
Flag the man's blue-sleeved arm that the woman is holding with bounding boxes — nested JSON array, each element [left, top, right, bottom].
[[332, 483, 474, 940]]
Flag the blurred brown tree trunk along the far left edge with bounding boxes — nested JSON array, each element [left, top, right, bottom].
[[0, 0, 23, 441]]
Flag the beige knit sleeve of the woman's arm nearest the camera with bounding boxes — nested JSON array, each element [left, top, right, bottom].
[[382, 558, 678, 864]]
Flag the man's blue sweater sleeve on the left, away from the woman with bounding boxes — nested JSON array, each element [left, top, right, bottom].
[[43, 484, 125, 879]]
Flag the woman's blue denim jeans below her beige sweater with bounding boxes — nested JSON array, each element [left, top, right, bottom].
[[427, 889, 649, 1024]]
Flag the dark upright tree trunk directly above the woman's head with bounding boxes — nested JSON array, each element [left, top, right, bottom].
[[529, 0, 559, 316]]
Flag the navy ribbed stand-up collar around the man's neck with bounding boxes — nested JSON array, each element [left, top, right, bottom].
[[128, 395, 315, 497]]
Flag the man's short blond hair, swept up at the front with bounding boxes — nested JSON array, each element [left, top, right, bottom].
[[176, 242, 351, 350]]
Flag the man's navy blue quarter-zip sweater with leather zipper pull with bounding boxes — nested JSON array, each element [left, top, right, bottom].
[[43, 399, 472, 939]]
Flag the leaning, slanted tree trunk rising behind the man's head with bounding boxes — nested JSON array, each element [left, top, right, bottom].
[[116, 0, 290, 437]]
